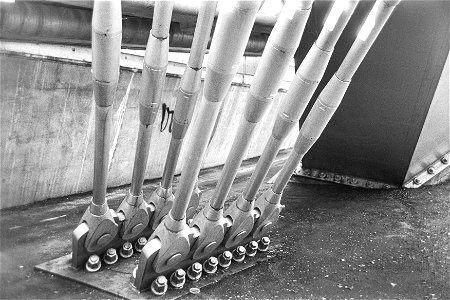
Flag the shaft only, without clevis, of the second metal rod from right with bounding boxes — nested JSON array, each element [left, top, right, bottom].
[[243, 1, 357, 202]]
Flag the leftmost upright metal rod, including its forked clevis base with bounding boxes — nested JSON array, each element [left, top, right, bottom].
[[72, 0, 122, 267]]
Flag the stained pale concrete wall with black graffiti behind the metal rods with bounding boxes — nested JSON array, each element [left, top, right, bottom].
[[0, 48, 296, 208]]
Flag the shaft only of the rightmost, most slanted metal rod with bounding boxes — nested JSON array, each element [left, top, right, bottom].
[[272, 0, 400, 194]]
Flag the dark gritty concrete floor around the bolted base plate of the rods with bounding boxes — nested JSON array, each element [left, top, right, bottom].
[[0, 161, 450, 299]]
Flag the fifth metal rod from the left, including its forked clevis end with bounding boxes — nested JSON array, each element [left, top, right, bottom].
[[190, 0, 313, 258]]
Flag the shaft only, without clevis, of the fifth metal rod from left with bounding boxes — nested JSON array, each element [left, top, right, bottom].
[[210, 0, 313, 210]]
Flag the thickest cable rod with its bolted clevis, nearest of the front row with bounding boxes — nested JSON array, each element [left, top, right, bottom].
[[132, 1, 260, 290]]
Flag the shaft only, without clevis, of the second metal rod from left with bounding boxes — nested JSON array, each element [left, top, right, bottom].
[[130, 1, 173, 196]]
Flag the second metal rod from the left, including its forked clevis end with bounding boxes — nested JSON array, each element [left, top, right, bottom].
[[117, 1, 173, 241]]
